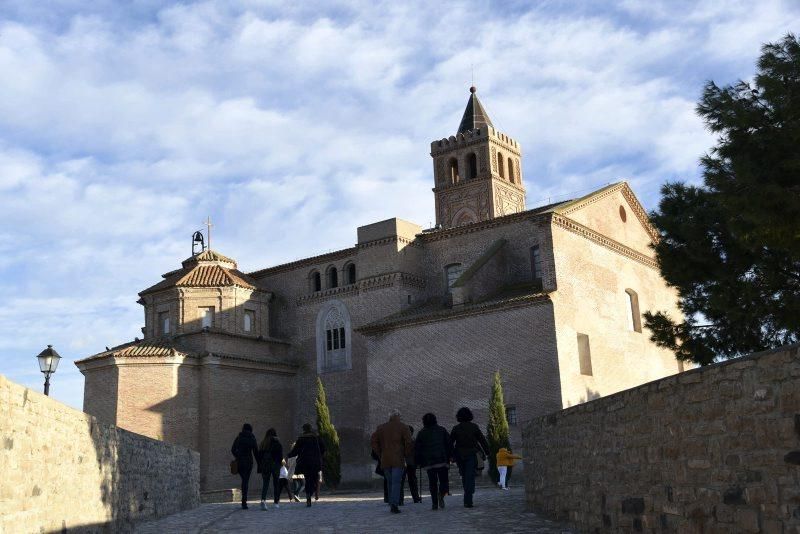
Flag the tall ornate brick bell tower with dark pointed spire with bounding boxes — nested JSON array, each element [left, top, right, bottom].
[[431, 86, 525, 228]]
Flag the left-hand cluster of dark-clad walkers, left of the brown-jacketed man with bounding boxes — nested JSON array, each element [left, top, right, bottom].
[[231, 423, 325, 510]]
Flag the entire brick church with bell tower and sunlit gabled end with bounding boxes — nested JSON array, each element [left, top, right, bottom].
[[76, 88, 682, 490]]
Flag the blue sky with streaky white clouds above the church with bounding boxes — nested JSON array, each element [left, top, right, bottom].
[[0, 0, 800, 408]]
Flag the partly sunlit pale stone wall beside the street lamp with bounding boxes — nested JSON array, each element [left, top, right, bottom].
[[0, 375, 200, 533]]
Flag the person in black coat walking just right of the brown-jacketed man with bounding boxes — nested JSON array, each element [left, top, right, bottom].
[[414, 413, 453, 510]]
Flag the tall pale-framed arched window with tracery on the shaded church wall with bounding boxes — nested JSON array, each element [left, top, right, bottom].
[[317, 300, 352, 373]]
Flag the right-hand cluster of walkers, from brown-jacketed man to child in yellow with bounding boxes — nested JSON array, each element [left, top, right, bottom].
[[370, 407, 521, 514]]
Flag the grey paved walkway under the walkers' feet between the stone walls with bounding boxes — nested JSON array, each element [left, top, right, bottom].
[[136, 488, 572, 534]]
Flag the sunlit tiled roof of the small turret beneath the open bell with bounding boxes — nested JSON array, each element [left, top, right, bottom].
[[139, 250, 257, 295]]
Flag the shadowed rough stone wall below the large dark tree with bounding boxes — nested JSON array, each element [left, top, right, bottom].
[[523, 345, 800, 533]]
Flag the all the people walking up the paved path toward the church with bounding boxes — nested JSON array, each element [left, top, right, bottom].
[[231, 407, 521, 514]]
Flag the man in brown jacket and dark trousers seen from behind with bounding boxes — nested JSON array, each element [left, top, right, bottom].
[[371, 410, 413, 514]]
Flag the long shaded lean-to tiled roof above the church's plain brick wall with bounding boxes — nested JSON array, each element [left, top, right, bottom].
[[356, 284, 550, 334]]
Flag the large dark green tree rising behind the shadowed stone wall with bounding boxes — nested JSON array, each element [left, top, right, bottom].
[[645, 34, 800, 364]]
